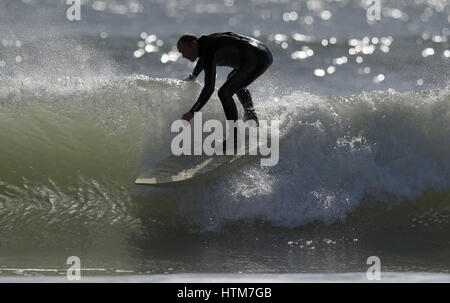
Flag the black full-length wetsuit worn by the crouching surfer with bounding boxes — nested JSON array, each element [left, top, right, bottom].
[[190, 32, 273, 121]]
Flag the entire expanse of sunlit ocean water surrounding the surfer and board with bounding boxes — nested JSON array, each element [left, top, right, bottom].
[[0, 0, 450, 282]]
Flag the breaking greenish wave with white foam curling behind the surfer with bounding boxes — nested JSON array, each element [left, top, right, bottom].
[[0, 76, 450, 247]]
